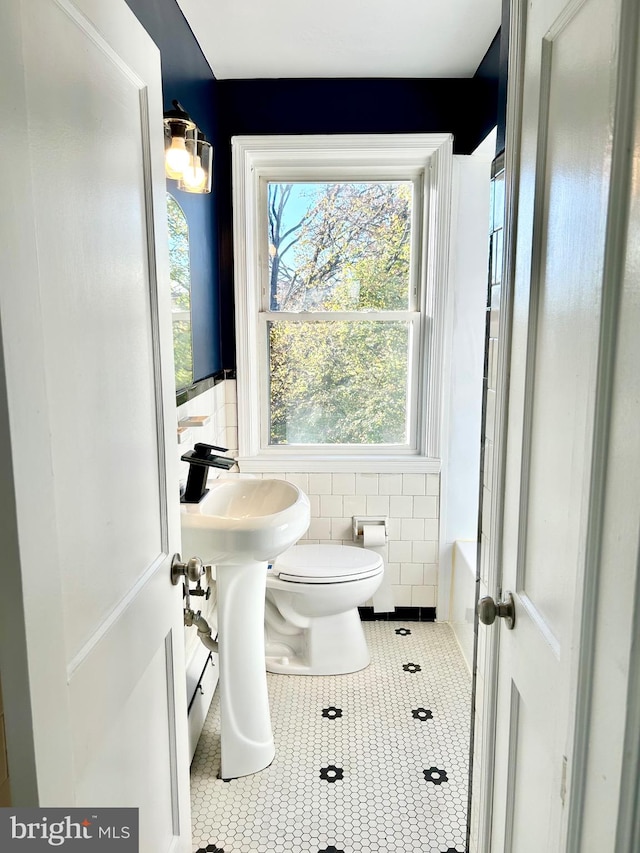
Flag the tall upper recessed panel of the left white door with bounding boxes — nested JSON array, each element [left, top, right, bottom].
[[24, 3, 166, 658]]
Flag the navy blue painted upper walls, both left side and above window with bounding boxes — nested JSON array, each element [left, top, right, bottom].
[[127, 0, 508, 372]]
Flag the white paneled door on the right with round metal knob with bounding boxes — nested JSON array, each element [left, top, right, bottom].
[[479, 0, 638, 853]]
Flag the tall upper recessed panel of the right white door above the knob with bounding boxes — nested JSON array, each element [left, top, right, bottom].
[[518, 2, 615, 643]]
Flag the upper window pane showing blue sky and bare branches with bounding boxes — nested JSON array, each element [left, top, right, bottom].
[[267, 181, 413, 311]]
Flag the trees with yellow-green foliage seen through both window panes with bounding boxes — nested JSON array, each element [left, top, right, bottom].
[[269, 182, 411, 444]]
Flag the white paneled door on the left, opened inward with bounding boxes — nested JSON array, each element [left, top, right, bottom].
[[0, 0, 190, 853]]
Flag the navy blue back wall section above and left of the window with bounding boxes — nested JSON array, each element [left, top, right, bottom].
[[217, 78, 498, 367]]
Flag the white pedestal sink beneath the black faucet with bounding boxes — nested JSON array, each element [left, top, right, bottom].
[[181, 478, 309, 779]]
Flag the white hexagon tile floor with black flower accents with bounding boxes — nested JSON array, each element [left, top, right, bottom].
[[191, 621, 471, 853]]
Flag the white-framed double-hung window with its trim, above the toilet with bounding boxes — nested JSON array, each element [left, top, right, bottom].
[[233, 135, 451, 471]]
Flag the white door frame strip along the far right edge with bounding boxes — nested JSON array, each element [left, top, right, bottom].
[[567, 0, 640, 853]]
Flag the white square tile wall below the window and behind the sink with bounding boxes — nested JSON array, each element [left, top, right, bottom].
[[178, 379, 440, 607]]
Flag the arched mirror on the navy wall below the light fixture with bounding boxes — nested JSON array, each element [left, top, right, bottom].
[[167, 193, 193, 391]]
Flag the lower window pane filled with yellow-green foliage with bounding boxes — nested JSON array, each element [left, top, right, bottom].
[[267, 320, 410, 445]]
